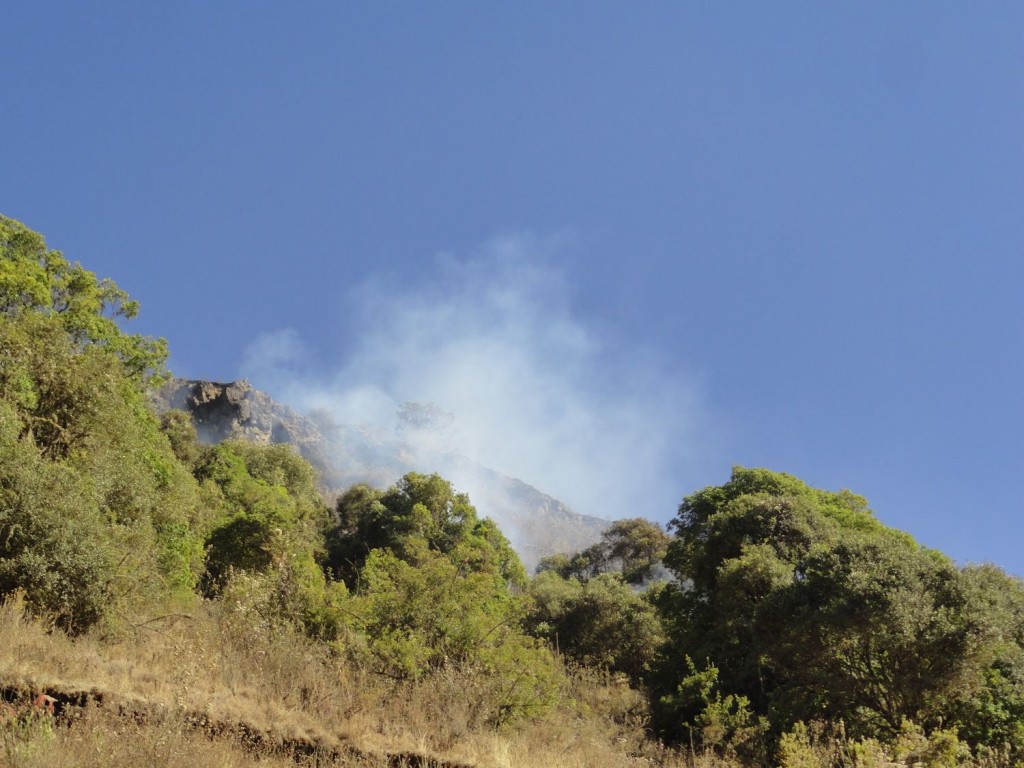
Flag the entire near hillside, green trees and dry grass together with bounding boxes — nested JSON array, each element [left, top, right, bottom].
[[0, 211, 1024, 768]]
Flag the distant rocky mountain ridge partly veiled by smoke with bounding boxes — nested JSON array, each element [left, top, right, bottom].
[[155, 379, 608, 569]]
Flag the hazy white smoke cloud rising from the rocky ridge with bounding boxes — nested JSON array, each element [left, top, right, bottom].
[[243, 236, 711, 520]]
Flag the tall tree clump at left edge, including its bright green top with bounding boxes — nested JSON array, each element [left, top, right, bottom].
[[0, 216, 192, 632]]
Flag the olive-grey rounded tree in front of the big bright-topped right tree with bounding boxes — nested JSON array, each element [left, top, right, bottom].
[[770, 535, 987, 736]]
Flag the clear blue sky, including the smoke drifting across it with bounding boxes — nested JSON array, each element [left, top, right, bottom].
[[0, 2, 1024, 574]]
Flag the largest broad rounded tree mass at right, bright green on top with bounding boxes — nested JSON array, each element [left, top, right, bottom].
[[654, 468, 988, 749]]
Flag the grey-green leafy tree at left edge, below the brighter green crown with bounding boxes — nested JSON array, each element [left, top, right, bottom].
[[0, 313, 202, 632]]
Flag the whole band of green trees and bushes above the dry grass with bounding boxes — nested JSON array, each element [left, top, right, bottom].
[[0, 217, 1024, 766]]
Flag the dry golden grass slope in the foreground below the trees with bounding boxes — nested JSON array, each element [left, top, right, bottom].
[[0, 600, 696, 768]]
